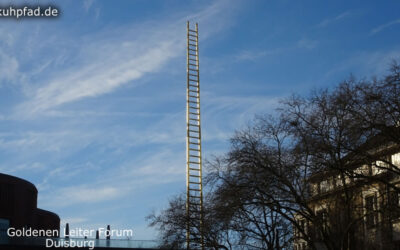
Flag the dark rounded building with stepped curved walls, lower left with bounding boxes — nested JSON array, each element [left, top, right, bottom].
[[0, 174, 60, 231]]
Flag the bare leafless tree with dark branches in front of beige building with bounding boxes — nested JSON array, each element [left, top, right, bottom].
[[150, 63, 400, 250]]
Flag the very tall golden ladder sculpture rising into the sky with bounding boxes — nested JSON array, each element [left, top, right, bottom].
[[186, 21, 204, 249]]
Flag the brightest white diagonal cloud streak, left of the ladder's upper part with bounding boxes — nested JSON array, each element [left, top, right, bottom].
[[21, 38, 179, 113]]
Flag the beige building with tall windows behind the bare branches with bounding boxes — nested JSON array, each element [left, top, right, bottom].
[[294, 144, 400, 250]]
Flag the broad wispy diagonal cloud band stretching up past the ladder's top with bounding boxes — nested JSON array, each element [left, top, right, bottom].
[[14, 1, 234, 115]]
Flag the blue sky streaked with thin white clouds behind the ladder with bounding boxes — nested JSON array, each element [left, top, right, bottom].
[[0, 0, 400, 239]]
